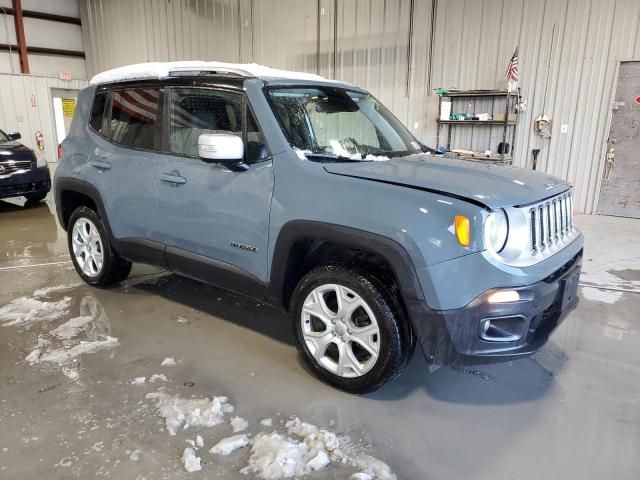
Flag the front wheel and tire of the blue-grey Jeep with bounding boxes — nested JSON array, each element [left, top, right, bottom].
[[290, 265, 411, 393]]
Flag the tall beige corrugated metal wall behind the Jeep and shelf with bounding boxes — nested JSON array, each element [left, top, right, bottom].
[[80, 0, 640, 213]]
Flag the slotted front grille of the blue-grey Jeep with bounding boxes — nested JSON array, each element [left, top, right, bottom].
[[529, 191, 574, 255]]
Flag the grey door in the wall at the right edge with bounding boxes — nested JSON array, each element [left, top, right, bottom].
[[598, 61, 640, 218]]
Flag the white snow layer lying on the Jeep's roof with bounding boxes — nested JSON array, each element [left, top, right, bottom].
[[89, 60, 330, 85]]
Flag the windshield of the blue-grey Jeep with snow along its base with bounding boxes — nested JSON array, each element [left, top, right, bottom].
[[268, 87, 422, 160]]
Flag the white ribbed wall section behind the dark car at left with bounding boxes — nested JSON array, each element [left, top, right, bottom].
[[0, 75, 87, 162]]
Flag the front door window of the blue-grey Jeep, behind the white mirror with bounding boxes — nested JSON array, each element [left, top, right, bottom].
[[169, 88, 242, 157]]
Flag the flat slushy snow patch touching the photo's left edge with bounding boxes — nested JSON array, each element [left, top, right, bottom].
[[0, 297, 71, 327]]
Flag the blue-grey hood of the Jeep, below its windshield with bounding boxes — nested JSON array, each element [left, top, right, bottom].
[[324, 154, 570, 208]]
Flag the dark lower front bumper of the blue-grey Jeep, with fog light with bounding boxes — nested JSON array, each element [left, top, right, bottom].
[[414, 250, 582, 365]]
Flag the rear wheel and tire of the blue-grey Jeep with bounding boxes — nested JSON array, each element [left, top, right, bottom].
[[67, 206, 131, 287]]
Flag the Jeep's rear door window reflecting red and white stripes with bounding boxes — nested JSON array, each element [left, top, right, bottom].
[[109, 88, 160, 149]]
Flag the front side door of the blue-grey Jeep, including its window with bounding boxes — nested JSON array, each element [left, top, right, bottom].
[[156, 87, 274, 288]]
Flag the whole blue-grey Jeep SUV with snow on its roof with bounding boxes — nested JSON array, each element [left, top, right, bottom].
[[54, 62, 583, 392]]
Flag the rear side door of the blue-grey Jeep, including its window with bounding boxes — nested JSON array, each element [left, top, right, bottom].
[[86, 88, 160, 242]]
